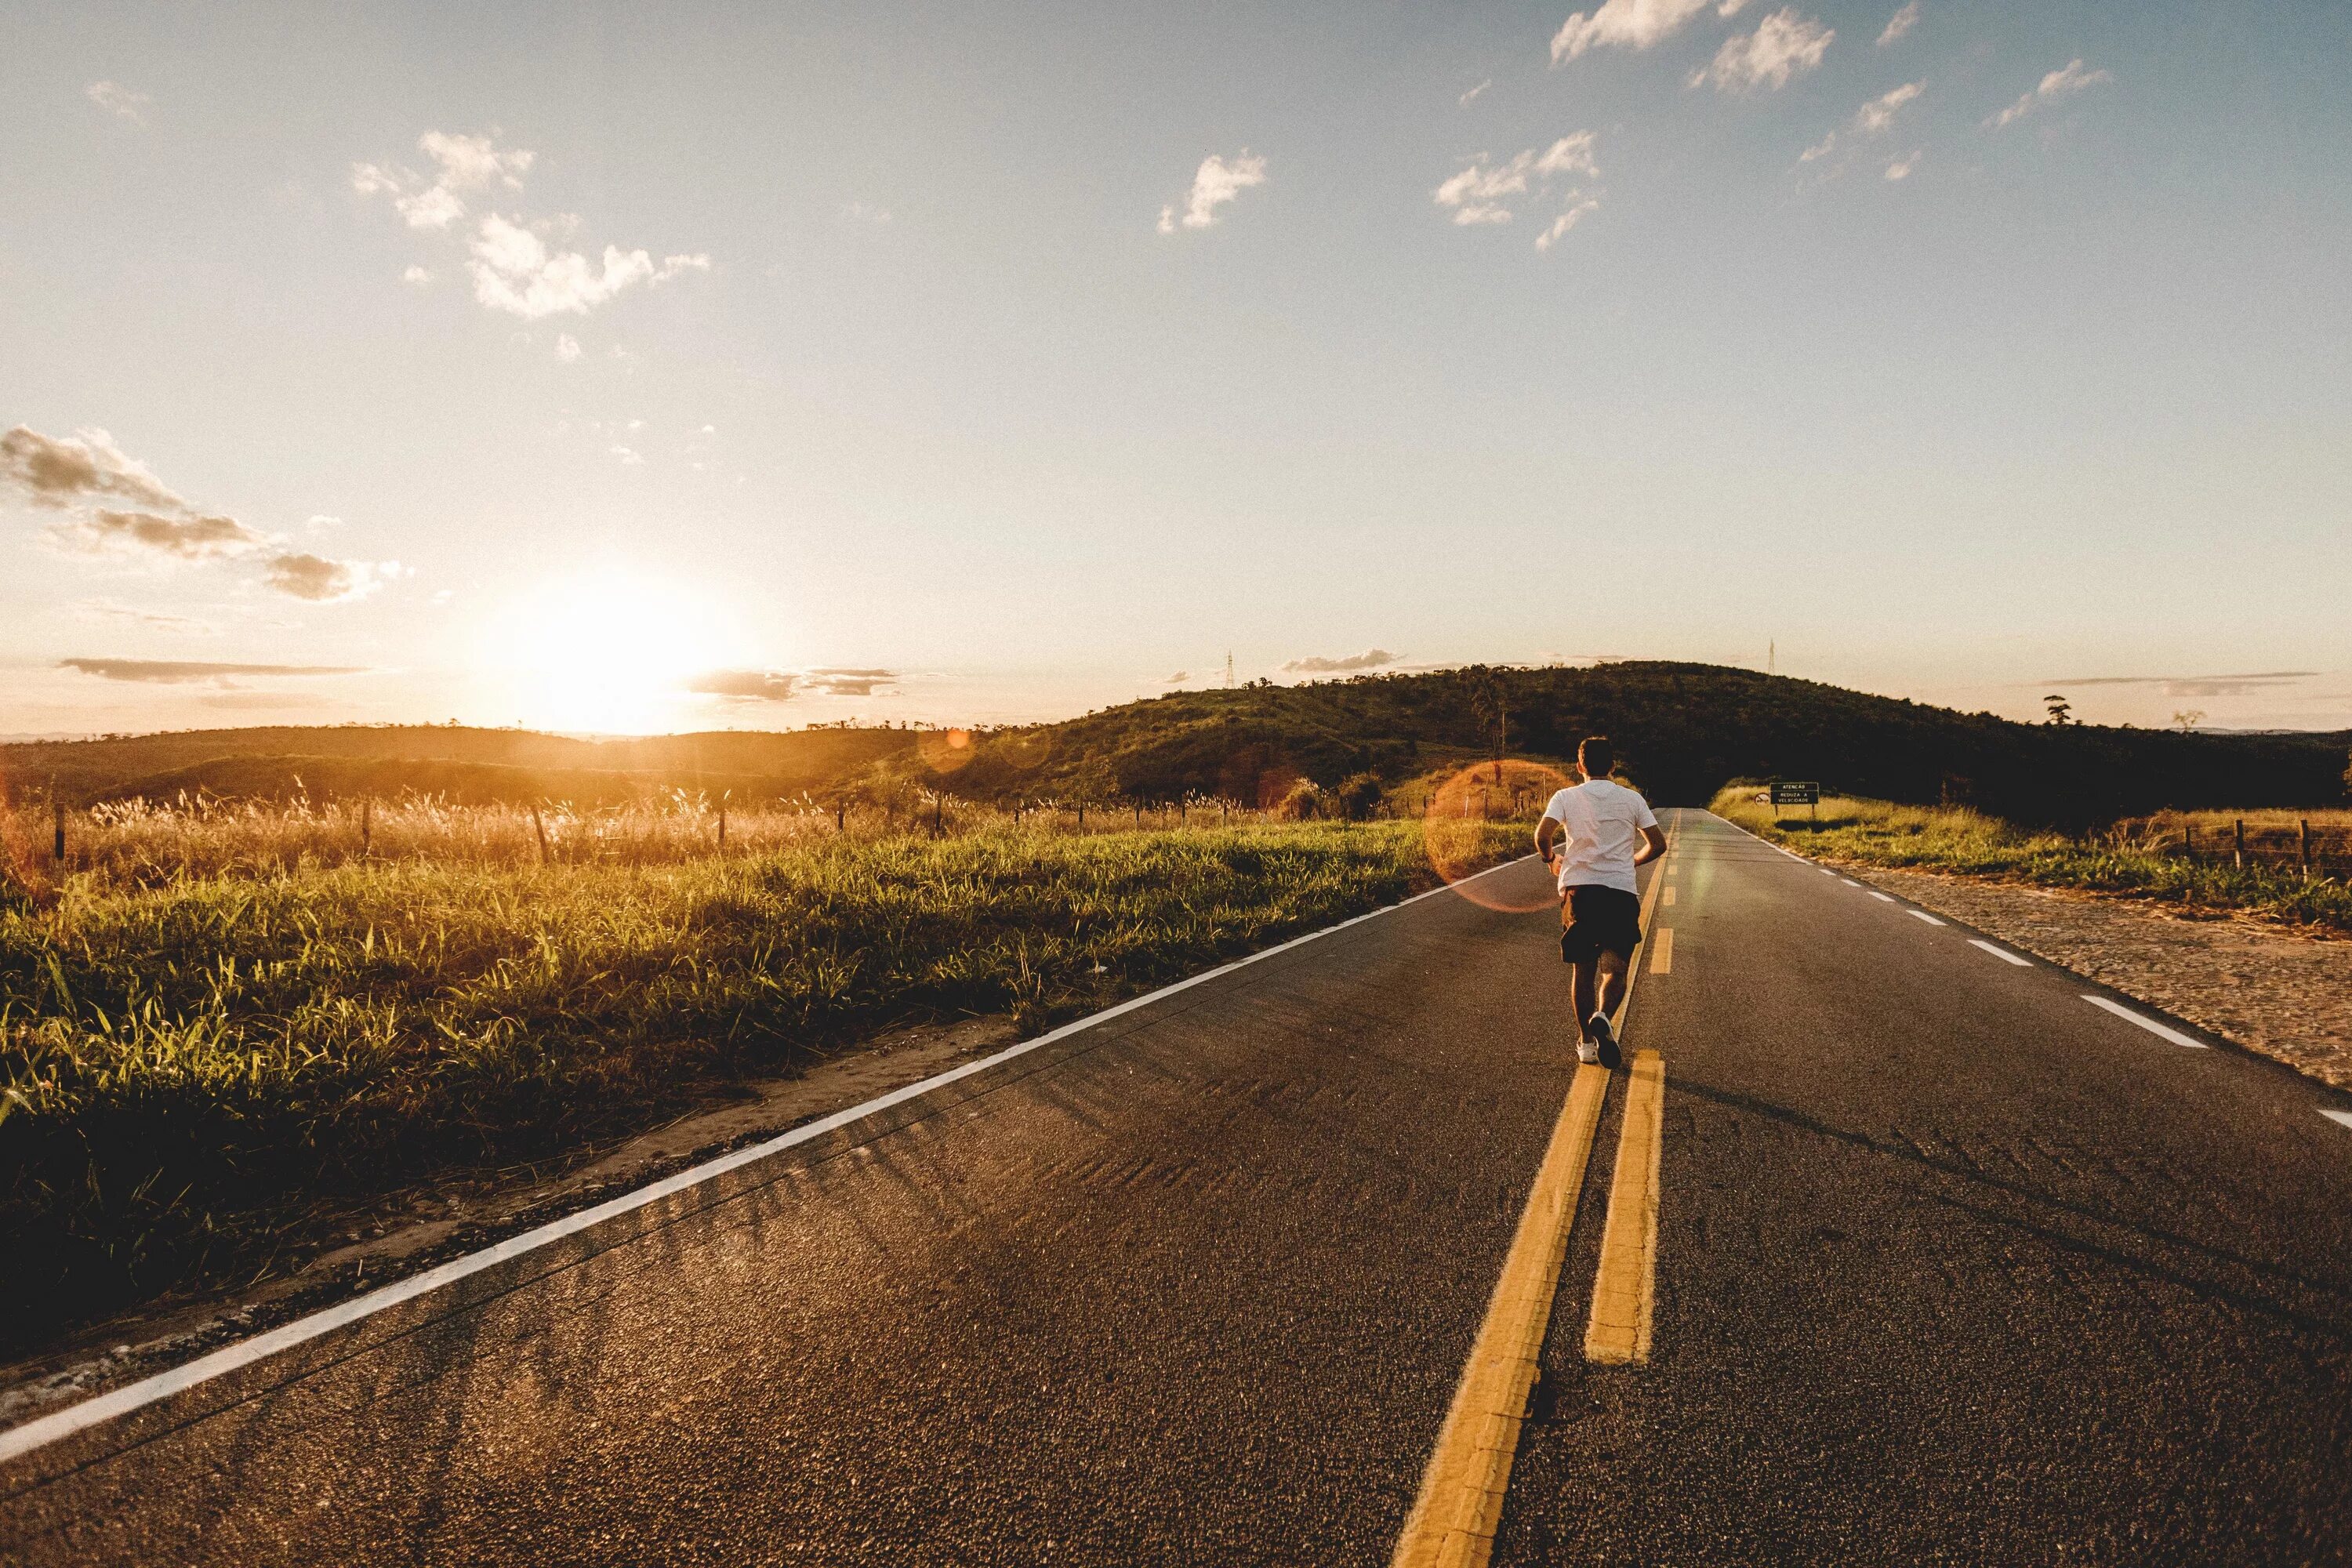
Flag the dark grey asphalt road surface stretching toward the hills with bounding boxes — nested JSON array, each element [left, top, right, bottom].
[[0, 813, 2352, 1568]]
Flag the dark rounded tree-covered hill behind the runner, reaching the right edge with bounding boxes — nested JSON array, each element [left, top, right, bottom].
[[889, 663, 2352, 827]]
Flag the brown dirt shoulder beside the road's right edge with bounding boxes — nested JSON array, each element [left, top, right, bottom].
[[1842, 862, 2352, 1088]]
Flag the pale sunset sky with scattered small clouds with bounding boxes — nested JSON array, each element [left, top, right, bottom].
[[0, 0, 2352, 734]]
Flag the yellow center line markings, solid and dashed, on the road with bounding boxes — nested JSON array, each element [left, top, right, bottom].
[[1392, 829, 1682, 1568]]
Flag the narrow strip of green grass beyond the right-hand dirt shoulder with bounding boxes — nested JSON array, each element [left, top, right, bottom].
[[1712, 785, 2352, 933]]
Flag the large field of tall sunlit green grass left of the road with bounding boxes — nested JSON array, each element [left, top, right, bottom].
[[0, 822, 1524, 1352]]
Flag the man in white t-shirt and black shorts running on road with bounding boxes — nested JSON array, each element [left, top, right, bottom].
[[1536, 736, 1665, 1067]]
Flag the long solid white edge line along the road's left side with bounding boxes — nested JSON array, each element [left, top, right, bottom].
[[0, 855, 1534, 1465]]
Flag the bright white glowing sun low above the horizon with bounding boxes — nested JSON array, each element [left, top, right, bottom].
[[489, 569, 724, 734]]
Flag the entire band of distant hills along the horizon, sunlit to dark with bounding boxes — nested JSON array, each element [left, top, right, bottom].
[[0, 661, 2352, 827]]
